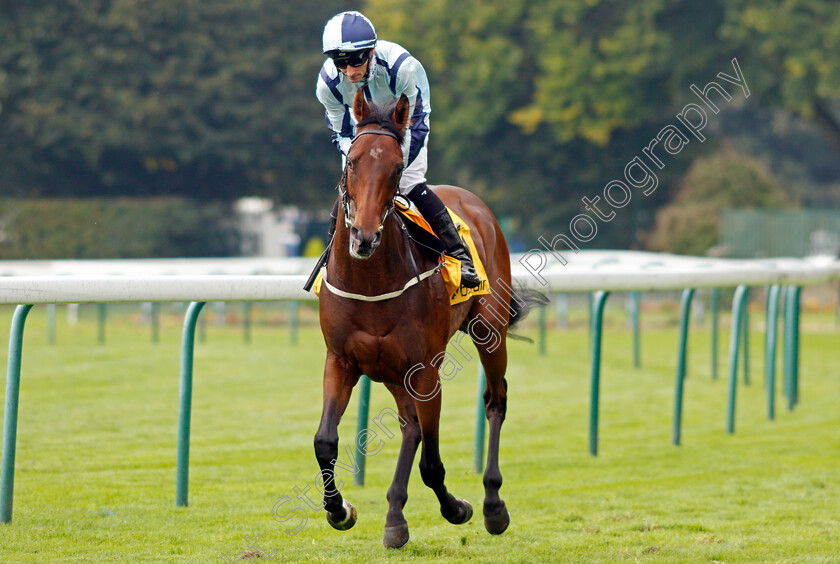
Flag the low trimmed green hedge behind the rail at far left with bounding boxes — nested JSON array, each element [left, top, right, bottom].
[[0, 198, 238, 259]]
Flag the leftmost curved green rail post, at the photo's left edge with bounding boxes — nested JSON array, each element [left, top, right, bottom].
[[0, 305, 32, 523]]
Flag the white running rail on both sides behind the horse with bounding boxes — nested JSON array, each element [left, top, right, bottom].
[[0, 251, 840, 304]]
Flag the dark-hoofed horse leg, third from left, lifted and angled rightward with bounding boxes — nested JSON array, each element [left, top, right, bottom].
[[410, 367, 472, 525]]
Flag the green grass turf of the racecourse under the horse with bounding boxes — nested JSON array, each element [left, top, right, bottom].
[[0, 307, 840, 563]]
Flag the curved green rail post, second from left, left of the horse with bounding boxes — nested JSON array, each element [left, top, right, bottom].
[[175, 302, 205, 507]]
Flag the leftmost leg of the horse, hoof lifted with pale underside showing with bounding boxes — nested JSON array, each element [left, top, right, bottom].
[[315, 352, 359, 531]]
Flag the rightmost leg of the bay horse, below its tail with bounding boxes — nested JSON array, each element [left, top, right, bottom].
[[478, 328, 510, 535]]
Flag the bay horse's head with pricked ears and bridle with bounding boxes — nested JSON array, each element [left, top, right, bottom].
[[345, 88, 409, 259]]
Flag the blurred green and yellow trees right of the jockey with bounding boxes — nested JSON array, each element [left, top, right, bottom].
[[368, 0, 840, 246]]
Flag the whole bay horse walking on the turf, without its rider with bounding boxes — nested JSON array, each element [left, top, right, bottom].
[[315, 89, 544, 548]]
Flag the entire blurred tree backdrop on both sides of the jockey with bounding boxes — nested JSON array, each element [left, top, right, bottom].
[[0, 0, 840, 247]]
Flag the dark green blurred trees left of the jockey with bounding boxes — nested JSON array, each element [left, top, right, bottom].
[[0, 0, 354, 203]]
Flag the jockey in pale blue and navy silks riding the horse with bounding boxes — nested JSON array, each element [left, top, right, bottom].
[[315, 12, 480, 288]]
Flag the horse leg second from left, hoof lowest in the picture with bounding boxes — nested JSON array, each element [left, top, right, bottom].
[[374, 384, 420, 548]]
